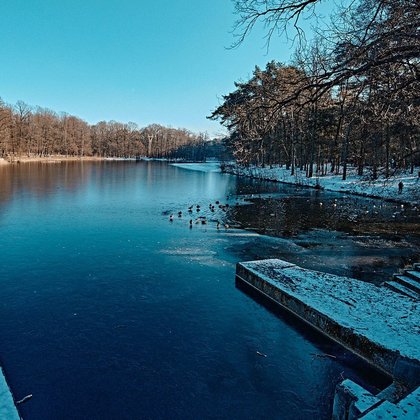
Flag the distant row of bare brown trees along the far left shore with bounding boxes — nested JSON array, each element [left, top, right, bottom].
[[0, 100, 226, 161]]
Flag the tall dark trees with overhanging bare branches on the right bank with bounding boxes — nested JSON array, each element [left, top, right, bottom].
[[209, 0, 420, 179]]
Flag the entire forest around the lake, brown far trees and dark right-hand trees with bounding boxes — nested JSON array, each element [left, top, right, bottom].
[[0, 0, 420, 179]]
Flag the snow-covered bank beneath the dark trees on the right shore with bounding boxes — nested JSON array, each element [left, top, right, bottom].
[[223, 164, 420, 204]]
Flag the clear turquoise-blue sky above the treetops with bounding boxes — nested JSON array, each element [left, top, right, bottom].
[[0, 0, 328, 135]]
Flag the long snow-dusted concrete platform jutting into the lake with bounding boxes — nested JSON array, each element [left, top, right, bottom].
[[236, 259, 420, 387]]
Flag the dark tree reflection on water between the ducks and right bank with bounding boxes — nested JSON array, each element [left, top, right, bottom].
[[229, 195, 420, 240]]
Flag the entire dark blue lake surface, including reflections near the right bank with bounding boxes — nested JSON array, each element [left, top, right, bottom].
[[0, 162, 420, 420]]
